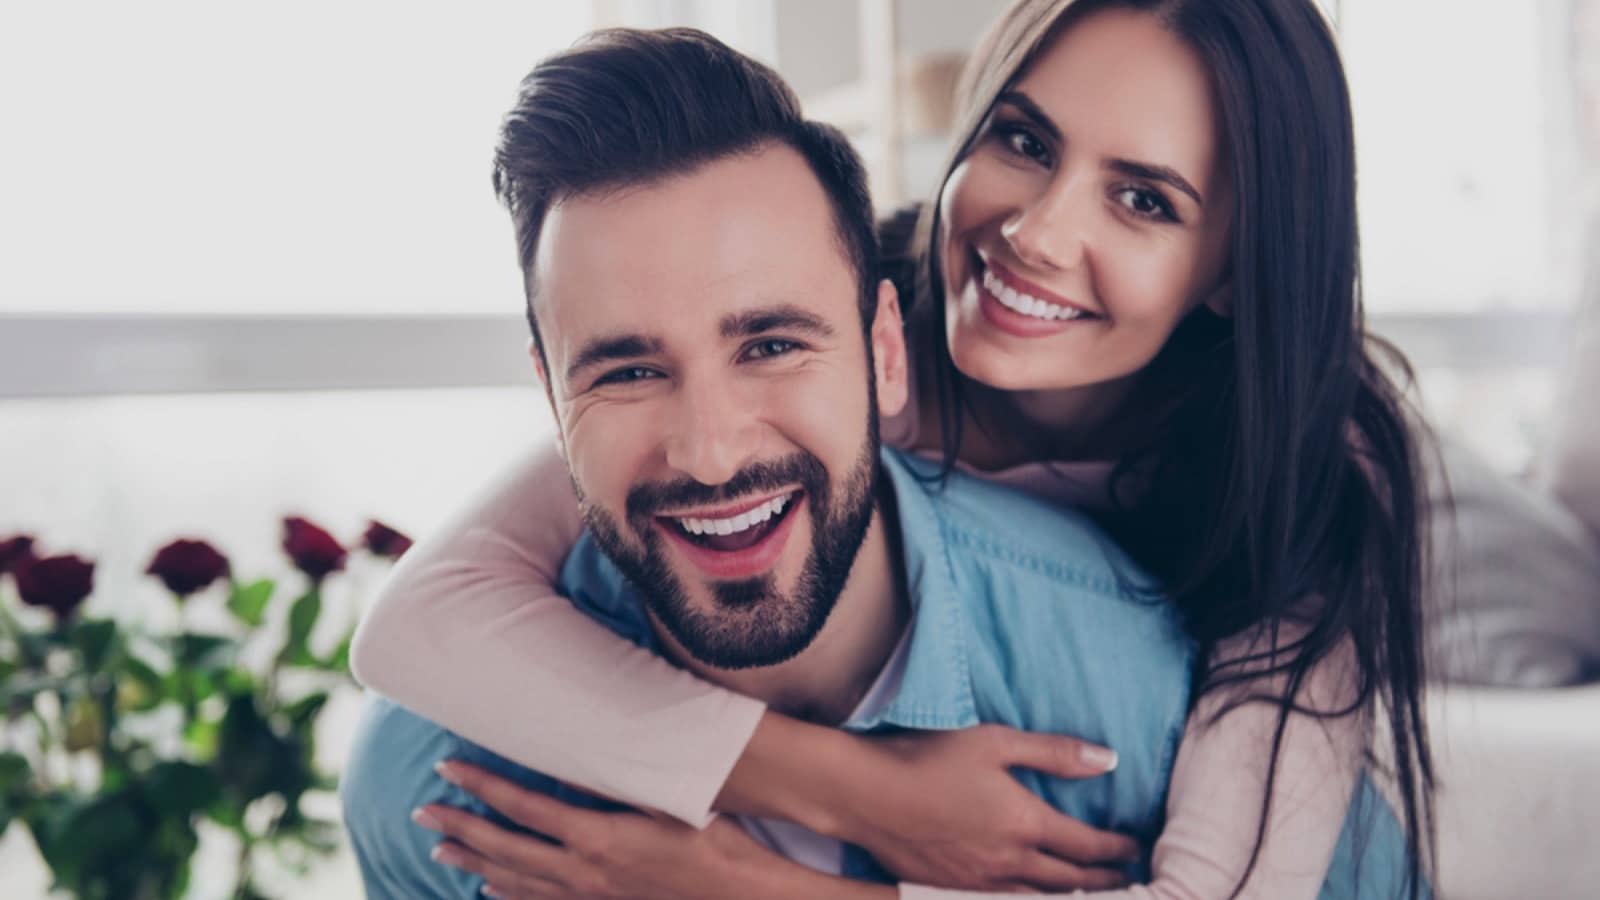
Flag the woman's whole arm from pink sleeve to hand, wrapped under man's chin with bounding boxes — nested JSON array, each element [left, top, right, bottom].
[[352, 448, 1152, 887]]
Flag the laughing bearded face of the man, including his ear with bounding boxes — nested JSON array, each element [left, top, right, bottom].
[[533, 146, 906, 669]]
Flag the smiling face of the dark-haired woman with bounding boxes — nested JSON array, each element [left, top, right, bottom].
[[938, 10, 1234, 405]]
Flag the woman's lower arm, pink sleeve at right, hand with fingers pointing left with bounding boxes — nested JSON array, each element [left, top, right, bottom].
[[418, 658, 1365, 900]]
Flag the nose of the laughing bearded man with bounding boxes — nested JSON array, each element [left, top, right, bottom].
[[667, 371, 760, 485]]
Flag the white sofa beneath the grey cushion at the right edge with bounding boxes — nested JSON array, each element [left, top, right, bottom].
[[1429, 218, 1600, 900]]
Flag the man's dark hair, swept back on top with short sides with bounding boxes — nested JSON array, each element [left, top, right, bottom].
[[494, 29, 878, 360]]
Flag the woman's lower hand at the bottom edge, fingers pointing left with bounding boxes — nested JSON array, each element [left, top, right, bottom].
[[414, 761, 896, 900]]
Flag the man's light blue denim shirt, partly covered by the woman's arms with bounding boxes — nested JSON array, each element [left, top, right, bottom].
[[341, 450, 1405, 900]]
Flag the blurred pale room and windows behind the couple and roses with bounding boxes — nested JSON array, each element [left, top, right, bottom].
[[0, 0, 1600, 898]]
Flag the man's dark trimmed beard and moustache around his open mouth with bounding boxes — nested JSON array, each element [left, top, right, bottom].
[[578, 432, 878, 669]]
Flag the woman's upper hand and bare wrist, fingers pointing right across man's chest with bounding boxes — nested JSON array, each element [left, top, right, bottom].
[[717, 713, 1139, 892]]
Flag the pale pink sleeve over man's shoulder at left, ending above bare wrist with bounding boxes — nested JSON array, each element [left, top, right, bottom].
[[350, 445, 765, 825]]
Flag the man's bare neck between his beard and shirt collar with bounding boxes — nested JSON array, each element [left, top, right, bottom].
[[651, 477, 910, 725]]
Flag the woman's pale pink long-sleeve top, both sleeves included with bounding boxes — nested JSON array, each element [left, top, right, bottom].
[[352, 405, 1366, 900]]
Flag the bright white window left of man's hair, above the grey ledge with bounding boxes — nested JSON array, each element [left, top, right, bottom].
[[0, 0, 592, 314]]
